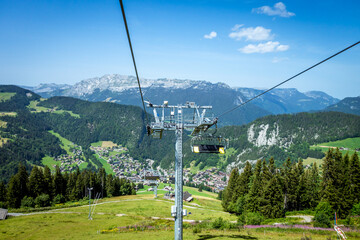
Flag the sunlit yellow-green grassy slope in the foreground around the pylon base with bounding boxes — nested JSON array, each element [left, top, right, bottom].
[[0, 195, 359, 240]]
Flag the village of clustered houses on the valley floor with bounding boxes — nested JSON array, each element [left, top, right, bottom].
[[54, 141, 229, 192]]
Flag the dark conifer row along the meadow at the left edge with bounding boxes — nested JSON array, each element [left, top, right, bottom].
[[0, 164, 136, 208]]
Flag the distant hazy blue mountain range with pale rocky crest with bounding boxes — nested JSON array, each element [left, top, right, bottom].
[[23, 74, 339, 125]]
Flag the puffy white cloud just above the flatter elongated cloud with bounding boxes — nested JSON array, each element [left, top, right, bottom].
[[229, 24, 273, 41]]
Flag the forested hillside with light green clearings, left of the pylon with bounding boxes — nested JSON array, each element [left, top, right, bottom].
[[0, 86, 145, 180]]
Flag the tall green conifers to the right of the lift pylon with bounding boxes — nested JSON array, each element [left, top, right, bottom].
[[219, 149, 360, 221]]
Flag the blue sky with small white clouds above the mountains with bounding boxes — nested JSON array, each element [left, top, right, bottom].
[[0, 0, 360, 98]]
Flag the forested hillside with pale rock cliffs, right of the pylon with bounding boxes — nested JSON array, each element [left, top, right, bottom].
[[220, 112, 360, 168]]
